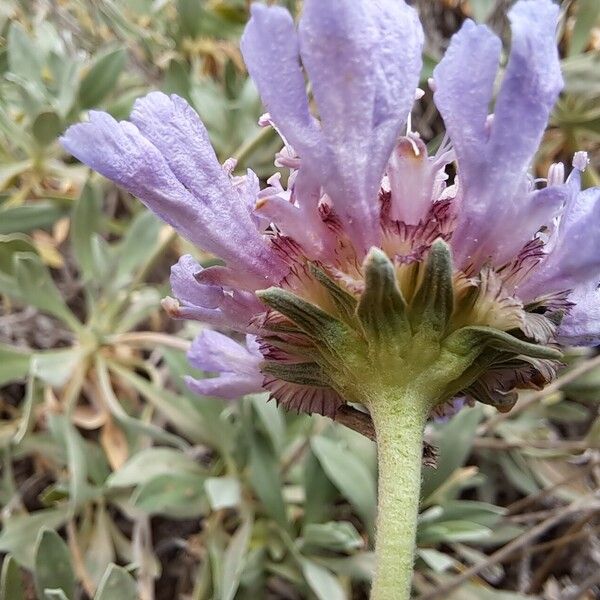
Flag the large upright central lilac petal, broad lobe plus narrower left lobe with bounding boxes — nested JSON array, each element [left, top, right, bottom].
[[242, 0, 423, 251]]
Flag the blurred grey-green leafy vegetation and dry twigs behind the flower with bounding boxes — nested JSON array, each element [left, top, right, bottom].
[[0, 0, 600, 600]]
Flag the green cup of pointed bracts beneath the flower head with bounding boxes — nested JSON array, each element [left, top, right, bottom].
[[257, 240, 561, 418]]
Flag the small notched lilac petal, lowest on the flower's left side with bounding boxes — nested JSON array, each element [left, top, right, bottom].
[[186, 330, 263, 399]]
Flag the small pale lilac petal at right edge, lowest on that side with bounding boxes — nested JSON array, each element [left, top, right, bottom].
[[558, 276, 600, 346]]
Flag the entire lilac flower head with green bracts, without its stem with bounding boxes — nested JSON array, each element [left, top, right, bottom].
[[62, 0, 600, 415]]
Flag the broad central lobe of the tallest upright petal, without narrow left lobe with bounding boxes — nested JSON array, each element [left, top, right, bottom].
[[297, 0, 423, 252]]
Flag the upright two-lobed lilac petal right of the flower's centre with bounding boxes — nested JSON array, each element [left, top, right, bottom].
[[435, 0, 562, 267]]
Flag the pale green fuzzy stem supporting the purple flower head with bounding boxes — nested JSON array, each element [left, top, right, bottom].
[[369, 390, 430, 600]]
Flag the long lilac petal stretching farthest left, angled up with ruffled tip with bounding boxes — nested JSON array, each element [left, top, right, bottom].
[[61, 92, 286, 286]]
